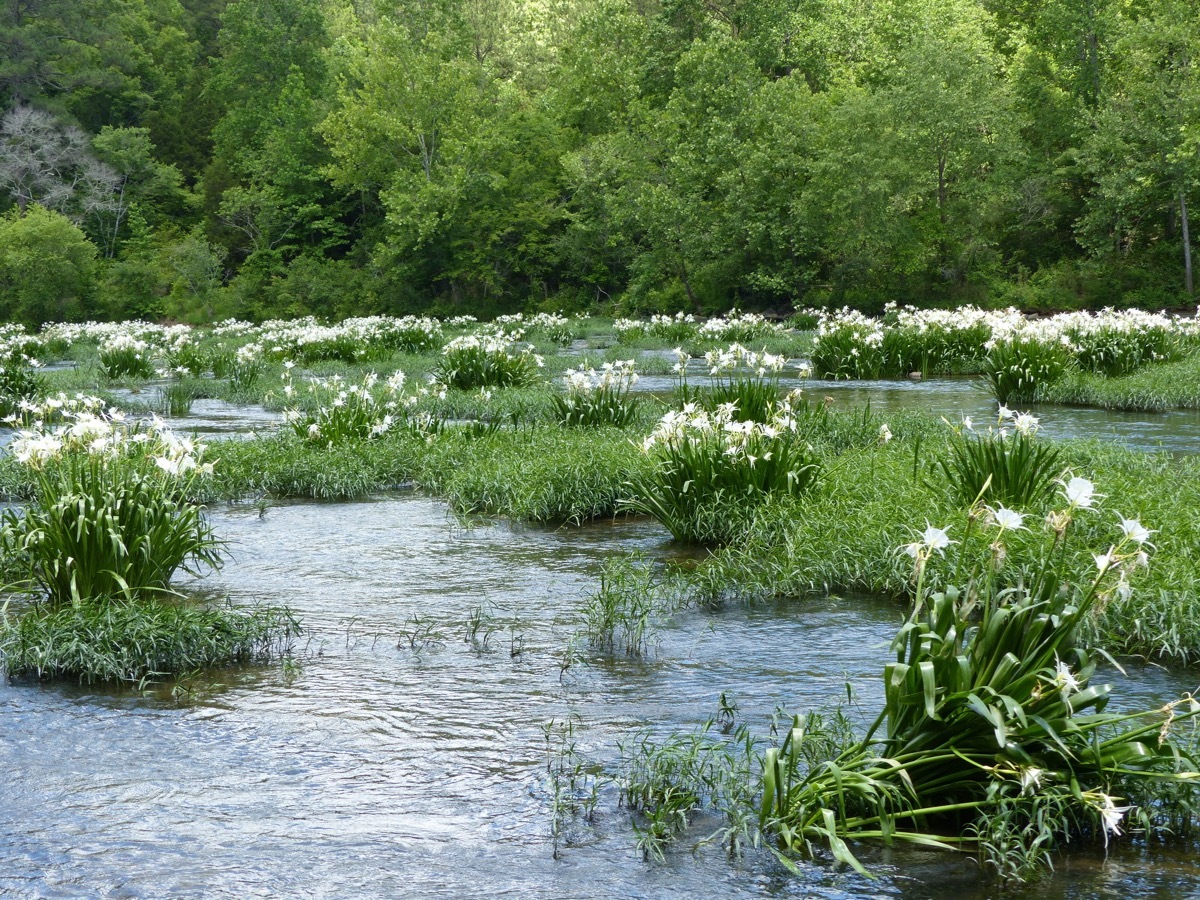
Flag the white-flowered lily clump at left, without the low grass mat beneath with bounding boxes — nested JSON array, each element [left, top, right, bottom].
[[0, 401, 221, 606]]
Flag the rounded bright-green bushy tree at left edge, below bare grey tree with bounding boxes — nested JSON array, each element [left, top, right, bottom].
[[0, 204, 96, 325]]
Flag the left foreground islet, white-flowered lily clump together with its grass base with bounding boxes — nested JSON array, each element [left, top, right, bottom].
[[0, 396, 299, 682]]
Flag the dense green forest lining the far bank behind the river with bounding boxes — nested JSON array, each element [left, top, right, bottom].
[[0, 0, 1200, 324]]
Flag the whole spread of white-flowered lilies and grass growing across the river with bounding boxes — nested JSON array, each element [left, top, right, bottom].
[[7, 308, 1200, 881]]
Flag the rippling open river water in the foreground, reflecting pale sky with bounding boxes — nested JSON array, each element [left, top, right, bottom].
[[0, 497, 1200, 898]]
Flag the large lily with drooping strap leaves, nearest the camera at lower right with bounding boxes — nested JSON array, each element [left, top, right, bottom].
[[760, 484, 1200, 877]]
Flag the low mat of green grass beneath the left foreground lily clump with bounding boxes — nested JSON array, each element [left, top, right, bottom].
[[0, 596, 300, 684]]
